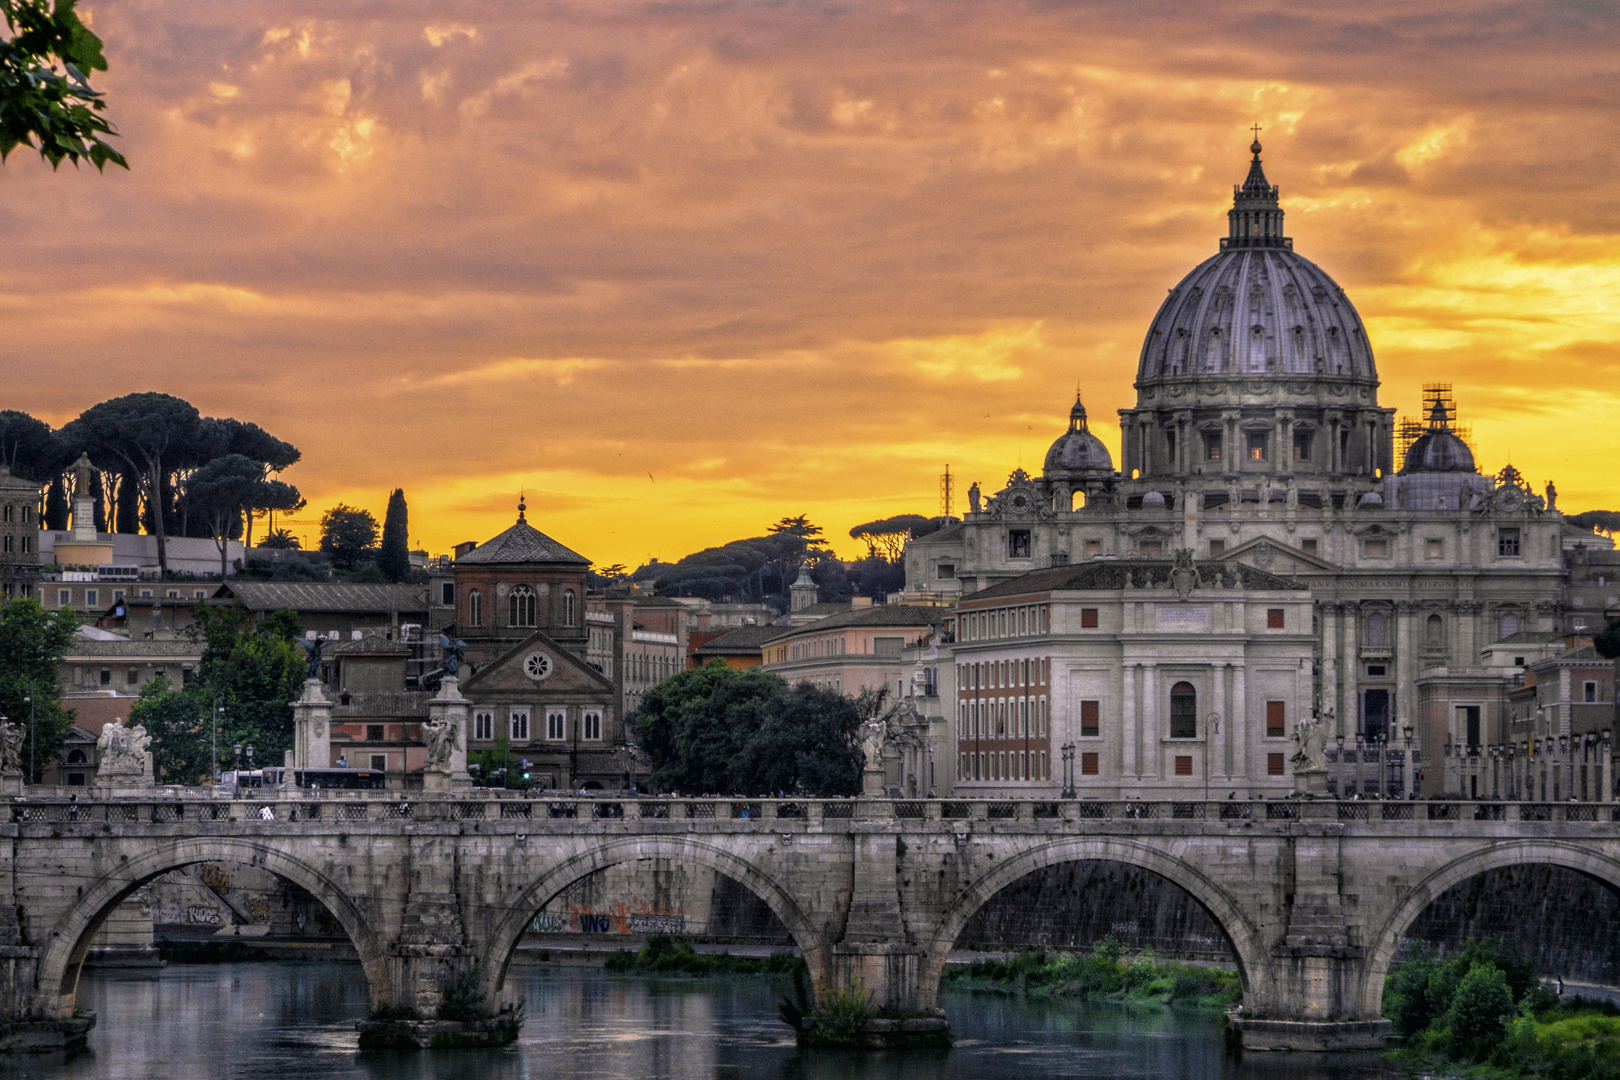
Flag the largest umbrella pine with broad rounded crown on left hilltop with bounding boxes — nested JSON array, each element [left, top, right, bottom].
[[63, 393, 203, 573]]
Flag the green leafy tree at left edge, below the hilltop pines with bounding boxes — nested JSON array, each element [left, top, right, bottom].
[[0, 597, 79, 782]]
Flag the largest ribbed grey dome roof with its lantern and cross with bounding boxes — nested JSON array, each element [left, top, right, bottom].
[[1136, 142, 1377, 385]]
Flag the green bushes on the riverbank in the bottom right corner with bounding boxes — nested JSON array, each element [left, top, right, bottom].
[[1383, 938, 1620, 1080]]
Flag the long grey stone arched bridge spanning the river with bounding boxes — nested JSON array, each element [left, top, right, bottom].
[[0, 792, 1620, 1048]]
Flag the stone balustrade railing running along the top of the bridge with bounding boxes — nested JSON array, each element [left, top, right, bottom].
[[6, 789, 1620, 834]]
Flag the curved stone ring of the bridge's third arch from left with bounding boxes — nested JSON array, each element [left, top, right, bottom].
[[917, 837, 1267, 1009]]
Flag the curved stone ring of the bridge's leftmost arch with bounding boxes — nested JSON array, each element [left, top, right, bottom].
[[39, 837, 389, 1017]]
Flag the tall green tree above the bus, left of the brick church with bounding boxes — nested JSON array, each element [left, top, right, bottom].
[[190, 604, 308, 764]]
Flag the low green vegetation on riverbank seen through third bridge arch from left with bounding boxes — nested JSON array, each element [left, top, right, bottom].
[[944, 938, 1243, 1009]]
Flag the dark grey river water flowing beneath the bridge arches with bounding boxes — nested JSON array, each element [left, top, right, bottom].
[[0, 963, 1398, 1080]]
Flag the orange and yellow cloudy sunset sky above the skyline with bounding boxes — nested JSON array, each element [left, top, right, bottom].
[[0, 0, 1620, 565]]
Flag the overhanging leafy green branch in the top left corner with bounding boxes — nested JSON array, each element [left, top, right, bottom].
[[0, 0, 130, 170]]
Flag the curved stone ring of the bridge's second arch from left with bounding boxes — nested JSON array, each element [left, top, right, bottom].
[[480, 836, 831, 1002]]
